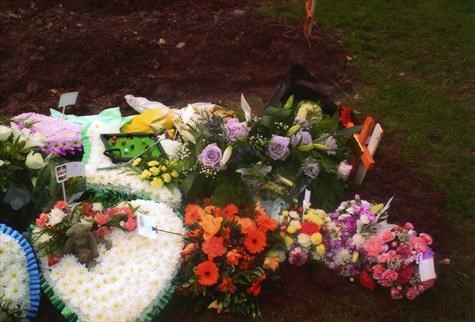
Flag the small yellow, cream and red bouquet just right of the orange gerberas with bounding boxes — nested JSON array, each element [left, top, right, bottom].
[[279, 208, 331, 266]]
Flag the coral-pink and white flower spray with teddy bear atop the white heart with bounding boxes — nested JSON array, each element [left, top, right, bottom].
[[32, 201, 137, 265]]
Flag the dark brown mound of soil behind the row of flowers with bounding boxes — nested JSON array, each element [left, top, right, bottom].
[[0, 0, 350, 115]]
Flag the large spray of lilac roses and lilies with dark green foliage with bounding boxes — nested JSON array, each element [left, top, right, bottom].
[[175, 97, 359, 205]]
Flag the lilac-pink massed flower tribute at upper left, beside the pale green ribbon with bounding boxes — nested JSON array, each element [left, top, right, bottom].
[[13, 113, 82, 156]]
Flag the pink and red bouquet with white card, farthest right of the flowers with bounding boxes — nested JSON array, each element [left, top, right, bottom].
[[360, 223, 436, 300]]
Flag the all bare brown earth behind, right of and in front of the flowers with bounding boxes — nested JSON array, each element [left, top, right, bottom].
[[0, 0, 454, 321]]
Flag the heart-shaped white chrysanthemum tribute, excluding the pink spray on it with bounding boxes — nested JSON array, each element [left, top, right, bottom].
[[37, 200, 184, 322]]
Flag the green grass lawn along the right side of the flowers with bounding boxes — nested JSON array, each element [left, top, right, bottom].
[[260, 0, 475, 321]]
